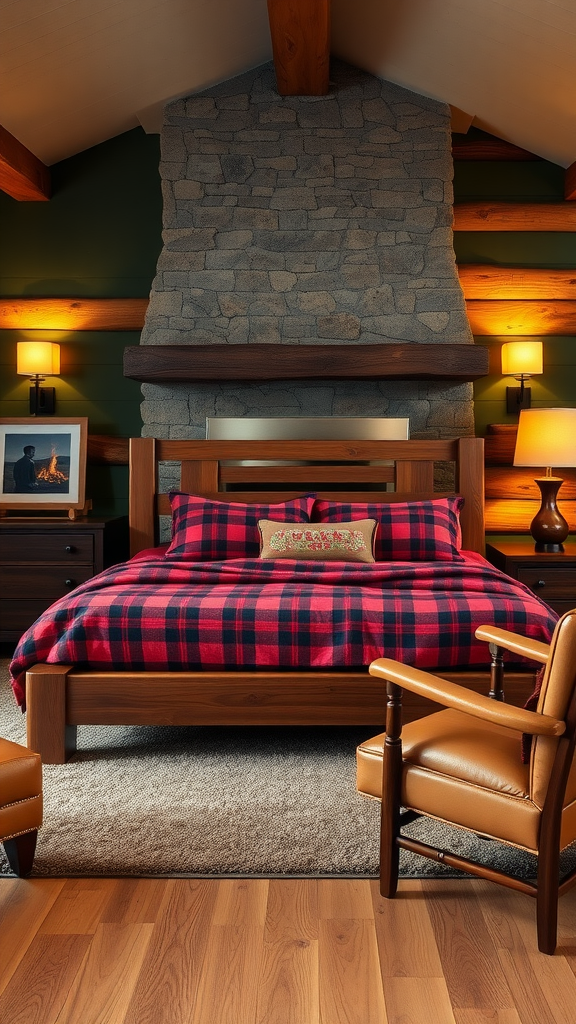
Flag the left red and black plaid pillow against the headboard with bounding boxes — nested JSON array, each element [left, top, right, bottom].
[[166, 490, 314, 562]]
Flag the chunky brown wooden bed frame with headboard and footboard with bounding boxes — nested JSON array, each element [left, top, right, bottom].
[[22, 437, 533, 764]]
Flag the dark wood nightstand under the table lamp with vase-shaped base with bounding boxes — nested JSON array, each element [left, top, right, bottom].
[[486, 538, 576, 615]]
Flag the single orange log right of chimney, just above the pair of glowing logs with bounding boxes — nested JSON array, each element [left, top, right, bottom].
[[454, 200, 576, 231]]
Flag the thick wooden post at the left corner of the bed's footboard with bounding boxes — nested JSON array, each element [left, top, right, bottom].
[[26, 665, 77, 765]]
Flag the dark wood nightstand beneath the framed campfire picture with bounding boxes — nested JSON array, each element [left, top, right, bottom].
[[0, 516, 128, 640]]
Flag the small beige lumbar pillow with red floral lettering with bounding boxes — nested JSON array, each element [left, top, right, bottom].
[[258, 519, 377, 562]]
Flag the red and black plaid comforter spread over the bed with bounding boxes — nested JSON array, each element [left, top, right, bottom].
[[11, 555, 558, 706]]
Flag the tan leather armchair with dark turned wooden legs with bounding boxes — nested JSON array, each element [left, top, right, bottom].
[[358, 608, 576, 953]]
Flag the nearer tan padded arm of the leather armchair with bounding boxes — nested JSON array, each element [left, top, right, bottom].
[[369, 657, 566, 736]]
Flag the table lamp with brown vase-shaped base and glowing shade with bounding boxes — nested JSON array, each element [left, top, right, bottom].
[[513, 409, 576, 551]]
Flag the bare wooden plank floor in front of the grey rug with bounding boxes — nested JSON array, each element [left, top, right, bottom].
[[0, 879, 576, 1024]]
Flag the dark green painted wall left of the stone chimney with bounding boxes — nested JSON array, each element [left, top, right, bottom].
[[0, 128, 162, 514]]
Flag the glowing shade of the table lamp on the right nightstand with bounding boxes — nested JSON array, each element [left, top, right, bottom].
[[513, 409, 576, 467]]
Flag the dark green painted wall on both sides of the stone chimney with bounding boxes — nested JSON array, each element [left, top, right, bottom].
[[0, 128, 576, 513]]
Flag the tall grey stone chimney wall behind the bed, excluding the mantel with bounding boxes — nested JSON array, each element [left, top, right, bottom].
[[141, 63, 474, 437]]
